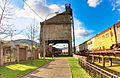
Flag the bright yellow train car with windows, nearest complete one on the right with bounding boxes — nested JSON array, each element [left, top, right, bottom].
[[94, 25, 116, 50]]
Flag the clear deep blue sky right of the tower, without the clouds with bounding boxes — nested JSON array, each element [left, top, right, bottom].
[[71, 0, 120, 44]]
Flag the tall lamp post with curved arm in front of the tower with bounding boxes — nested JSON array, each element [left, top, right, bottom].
[[43, 12, 59, 62]]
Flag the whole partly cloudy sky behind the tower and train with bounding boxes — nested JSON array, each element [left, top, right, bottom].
[[0, 0, 120, 46]]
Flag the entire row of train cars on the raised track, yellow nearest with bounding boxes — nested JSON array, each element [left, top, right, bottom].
[[79, 21, 120, 54]]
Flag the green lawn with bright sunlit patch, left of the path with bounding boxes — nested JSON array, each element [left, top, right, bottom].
[[0, 58, 52, 78]]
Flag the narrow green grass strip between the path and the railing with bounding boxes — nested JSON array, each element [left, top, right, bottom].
[[68, 57, 90, 78]]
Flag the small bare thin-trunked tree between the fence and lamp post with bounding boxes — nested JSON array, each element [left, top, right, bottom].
[[26, 24, 39, 64]]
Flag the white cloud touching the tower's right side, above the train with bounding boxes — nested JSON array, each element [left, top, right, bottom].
[[74, 18, 93, 37]]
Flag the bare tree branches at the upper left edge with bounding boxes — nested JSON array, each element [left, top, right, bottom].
[[0, 0, 13, 35]]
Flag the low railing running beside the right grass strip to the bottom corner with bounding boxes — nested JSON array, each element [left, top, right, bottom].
[[79, 57, 120, 78]]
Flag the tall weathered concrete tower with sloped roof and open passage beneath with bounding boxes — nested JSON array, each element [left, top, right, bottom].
[[40, 5, 72, 56]]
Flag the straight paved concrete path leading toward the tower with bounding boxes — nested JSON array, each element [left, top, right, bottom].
[[22, 58, 72, 78]]
